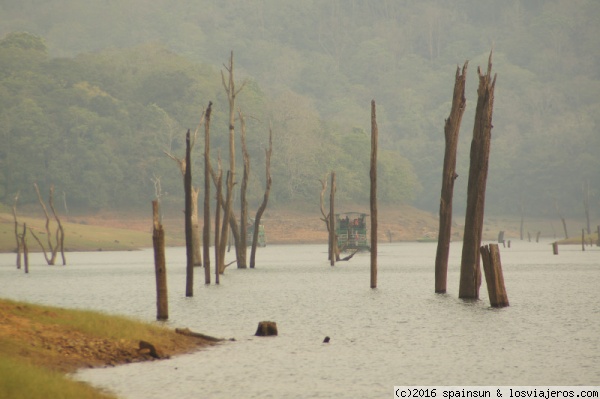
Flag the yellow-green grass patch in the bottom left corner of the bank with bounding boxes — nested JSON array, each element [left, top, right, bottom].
[[0, 356, 116, 399]]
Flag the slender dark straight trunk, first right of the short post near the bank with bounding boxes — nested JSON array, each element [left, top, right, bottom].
[[184, 129, 194, 297]]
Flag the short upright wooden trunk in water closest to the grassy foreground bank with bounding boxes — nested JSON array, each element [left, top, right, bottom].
[[152, 200, 169, 320]]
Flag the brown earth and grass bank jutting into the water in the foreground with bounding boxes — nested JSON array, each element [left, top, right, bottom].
[[0, 299, 214, 399]]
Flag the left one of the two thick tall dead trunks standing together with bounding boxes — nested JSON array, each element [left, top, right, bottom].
[[435, 61, 468, 294]]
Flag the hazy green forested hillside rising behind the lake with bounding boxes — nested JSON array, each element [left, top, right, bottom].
[[0, 0, 600, 216]]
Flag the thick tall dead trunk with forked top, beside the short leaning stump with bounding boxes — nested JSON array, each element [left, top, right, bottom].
[[458, 52, 496, 299]]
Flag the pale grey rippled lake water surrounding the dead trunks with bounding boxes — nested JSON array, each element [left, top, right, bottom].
[[0, 241, 600, 399]]
